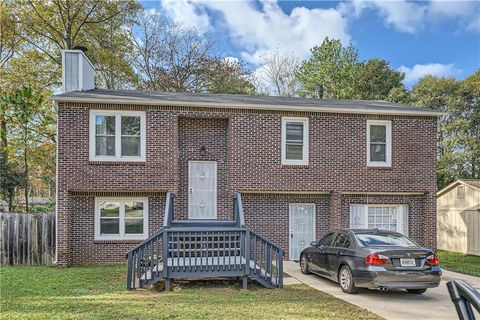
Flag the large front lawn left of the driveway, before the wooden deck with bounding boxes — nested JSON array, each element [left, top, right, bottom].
[[0, 265, 381, 319]]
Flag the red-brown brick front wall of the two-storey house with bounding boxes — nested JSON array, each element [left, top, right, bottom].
[[57, 103, 437, 265]]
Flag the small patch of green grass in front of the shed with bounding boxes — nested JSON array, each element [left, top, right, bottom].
[[437, 250, 480, 277]]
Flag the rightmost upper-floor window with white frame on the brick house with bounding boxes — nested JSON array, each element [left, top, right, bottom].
[[367, 120, 392, 167]]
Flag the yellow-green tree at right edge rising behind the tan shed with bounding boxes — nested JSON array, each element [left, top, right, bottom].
[[412, 71, 480, 188]]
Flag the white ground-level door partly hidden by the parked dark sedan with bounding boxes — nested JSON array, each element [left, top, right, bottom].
[[289, 203, 316, 260]]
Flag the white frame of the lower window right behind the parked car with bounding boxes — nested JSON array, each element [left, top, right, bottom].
[[350, 203, 410, 236]]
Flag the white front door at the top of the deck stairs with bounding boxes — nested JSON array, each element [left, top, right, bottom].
[[188, 161, 217, 219]]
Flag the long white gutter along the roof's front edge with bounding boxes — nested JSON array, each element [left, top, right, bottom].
[[51, 97, 444, 117]]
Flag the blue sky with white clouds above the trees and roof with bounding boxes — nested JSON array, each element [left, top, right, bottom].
[[143, 0, 480, 87]]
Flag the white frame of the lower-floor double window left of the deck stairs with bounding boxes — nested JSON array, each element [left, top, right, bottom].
[[95, 197, 148, 240]]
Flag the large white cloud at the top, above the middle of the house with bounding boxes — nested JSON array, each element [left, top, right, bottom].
[[162, 0, 350, 65]]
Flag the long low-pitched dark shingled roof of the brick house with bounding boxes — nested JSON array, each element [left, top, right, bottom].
[[51, 89, 443, 117]]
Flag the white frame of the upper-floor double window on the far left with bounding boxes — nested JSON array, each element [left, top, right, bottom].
[[89, 110, 147, 162]]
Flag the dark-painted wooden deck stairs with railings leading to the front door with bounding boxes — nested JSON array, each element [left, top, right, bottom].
[[125, 193, 284, 290]]
